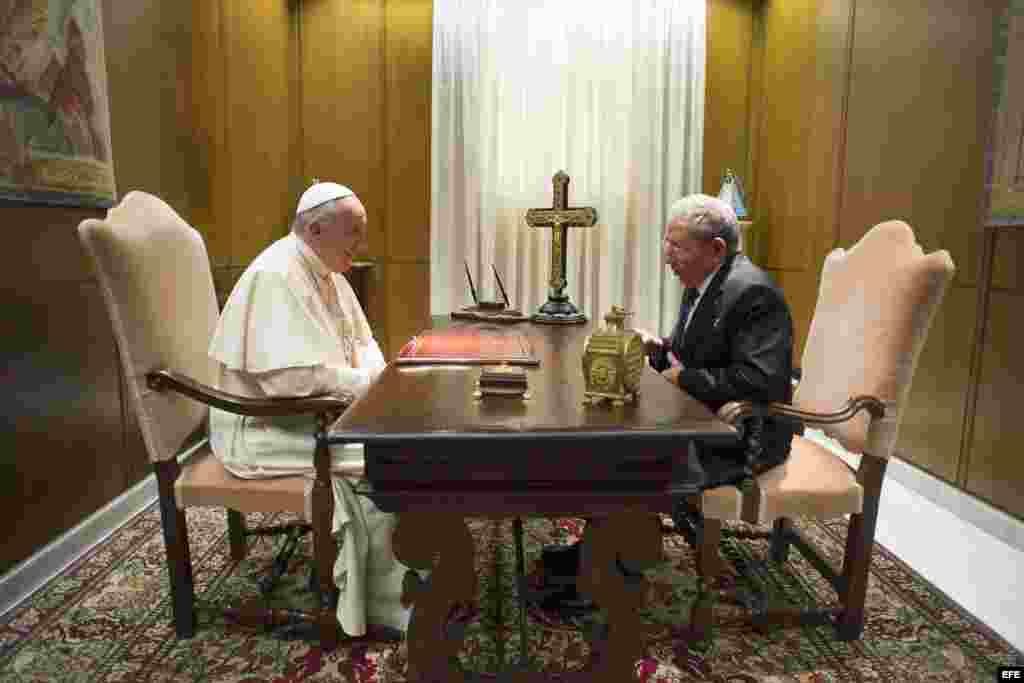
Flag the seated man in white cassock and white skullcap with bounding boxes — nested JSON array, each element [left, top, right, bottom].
[[210, 182, 410, 636]]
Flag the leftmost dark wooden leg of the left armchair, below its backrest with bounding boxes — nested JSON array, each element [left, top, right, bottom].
[[154, 458, 196, 638]]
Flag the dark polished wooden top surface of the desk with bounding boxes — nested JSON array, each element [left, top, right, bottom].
[[331, 323, 736, 444]]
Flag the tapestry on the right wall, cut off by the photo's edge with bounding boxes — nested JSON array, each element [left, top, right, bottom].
[[988, 0, 1024, 222]]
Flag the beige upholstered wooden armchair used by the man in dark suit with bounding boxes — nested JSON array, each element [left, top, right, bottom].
[[684, 221, 954, 640]]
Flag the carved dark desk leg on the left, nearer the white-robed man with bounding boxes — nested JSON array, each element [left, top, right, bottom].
[[393, 512, 476, 683]]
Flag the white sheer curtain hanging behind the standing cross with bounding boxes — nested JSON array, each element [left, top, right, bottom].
[[430, 0, 707, 334]]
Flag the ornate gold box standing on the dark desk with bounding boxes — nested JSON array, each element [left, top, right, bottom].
[[583, 306, 644, 405]]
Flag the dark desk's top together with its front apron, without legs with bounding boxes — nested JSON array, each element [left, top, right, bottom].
[[329, 323, 738, 516]]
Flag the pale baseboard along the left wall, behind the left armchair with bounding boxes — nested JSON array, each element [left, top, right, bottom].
[[0, 474, 157, 622]]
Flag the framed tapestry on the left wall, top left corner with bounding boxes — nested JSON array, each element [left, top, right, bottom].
[[0, 0, 115, 208]]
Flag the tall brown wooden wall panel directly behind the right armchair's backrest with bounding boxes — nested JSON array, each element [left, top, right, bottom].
[[839, 0, 994, 481]]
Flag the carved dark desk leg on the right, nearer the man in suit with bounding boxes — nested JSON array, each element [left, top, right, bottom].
[[579, 512, 662, 682]]
